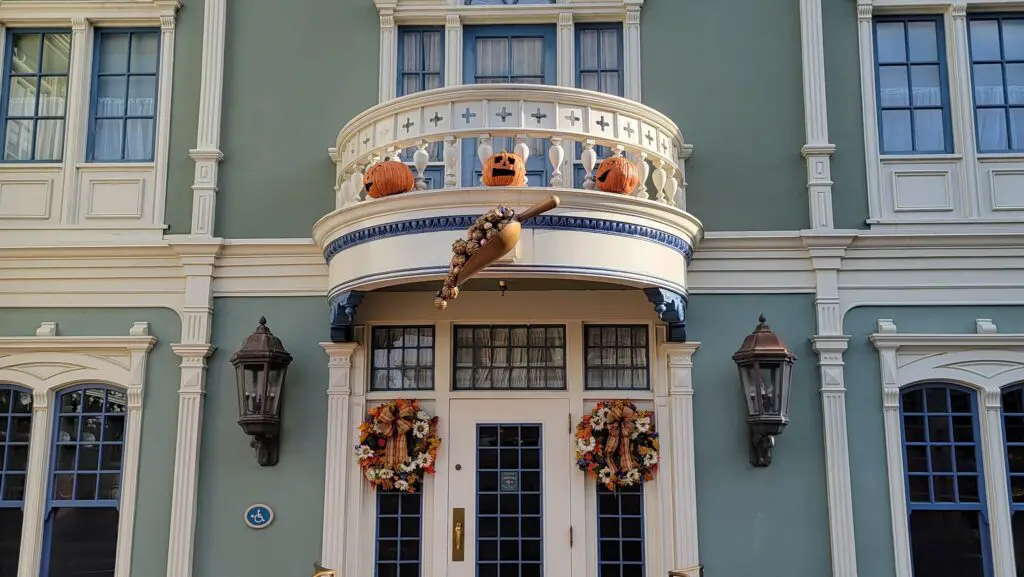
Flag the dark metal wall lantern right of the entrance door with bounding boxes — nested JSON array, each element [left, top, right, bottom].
[[732, 315, 797, 466]]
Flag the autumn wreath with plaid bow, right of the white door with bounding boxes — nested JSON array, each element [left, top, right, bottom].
[[575, 400, 658, 491]]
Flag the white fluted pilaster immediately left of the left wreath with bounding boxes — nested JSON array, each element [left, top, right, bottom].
[[321, 342, 359, 575]]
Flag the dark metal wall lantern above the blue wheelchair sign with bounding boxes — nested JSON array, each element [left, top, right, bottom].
[[231, 317, 292, 466]]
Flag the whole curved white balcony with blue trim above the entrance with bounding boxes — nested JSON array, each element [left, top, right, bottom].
[[313, 84, 702, 313]]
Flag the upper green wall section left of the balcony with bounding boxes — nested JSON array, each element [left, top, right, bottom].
[[216, 0, 380, 238]]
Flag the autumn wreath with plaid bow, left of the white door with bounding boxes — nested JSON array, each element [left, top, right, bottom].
[[355, 399, 441, 493]]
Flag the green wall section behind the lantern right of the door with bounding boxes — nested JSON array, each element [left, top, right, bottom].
[[687, 294, 827, 577]]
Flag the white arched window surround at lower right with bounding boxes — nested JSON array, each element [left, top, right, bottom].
[[870, 319, 1024, 577]]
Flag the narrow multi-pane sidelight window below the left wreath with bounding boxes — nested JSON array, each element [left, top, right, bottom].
[[375, 491, 423, 577]]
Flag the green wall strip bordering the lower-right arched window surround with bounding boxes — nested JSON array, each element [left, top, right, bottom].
[[844, 306, 1024, 577]]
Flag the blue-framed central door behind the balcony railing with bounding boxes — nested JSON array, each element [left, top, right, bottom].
[[462, 25, 556, 187]]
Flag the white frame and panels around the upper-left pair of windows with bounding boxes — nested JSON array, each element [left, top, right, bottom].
[[0, 0, 181, 245]]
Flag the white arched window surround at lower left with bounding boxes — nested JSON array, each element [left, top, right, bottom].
[[0, 323, 157, 577]]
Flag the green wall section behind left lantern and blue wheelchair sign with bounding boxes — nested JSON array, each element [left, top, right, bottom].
[[194, 297, 328, 577]]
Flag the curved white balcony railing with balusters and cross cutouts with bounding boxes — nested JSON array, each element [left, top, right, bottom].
[[330, 84, 691, 208]]
